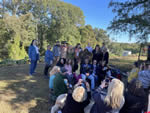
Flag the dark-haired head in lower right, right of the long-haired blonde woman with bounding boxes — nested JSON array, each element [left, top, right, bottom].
[[128, 79, 145, 96]]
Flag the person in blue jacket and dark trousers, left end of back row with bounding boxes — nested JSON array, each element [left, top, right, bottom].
[[44, 45, 53, 78]]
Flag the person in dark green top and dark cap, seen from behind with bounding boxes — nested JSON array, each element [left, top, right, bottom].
[[53, 67, 68, 97]]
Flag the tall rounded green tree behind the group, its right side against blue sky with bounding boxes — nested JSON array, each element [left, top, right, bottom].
[[48, 0, 84, 45]]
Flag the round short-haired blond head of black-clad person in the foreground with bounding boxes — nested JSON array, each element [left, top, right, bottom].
[[72, 86, 87, 102]]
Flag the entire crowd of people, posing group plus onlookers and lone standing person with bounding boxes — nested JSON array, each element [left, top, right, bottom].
[[29, 40, 150, 113]]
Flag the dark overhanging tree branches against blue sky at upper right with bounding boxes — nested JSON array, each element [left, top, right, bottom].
[[108, 0, 150, 42]]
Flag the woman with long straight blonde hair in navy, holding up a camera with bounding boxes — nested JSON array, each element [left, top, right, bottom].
[[91, 79, 125, 113]]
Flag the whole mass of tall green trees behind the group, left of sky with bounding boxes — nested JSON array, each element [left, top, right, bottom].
[[0, 0, 110, 60]]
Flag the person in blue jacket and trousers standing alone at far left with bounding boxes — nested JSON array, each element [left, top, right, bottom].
[[28, 40, 39, 76]]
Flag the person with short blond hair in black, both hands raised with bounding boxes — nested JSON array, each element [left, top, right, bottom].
[[62, 79, 91, 113]]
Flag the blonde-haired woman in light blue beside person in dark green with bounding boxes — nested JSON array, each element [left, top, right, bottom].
[[49, 66, 60, 90]]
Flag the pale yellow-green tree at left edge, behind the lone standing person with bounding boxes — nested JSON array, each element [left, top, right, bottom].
[[0, 14, 35, 60]]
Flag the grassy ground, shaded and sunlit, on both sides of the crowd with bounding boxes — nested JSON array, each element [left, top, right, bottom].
[[0, 57, 146, 113]]
